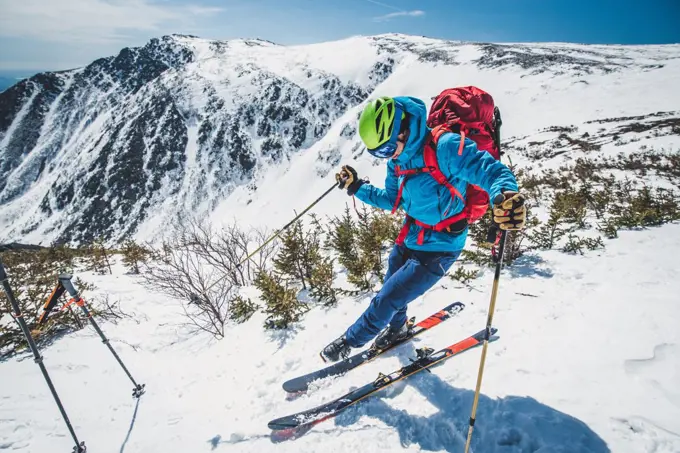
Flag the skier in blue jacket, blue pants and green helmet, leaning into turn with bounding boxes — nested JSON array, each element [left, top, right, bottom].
[[320, 97, 526, 362]]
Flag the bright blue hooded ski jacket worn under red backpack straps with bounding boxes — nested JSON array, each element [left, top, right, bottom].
[[356, 96, 518, 252]]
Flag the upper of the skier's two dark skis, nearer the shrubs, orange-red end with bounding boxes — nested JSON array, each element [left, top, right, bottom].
[[283, 302, 465, 393]]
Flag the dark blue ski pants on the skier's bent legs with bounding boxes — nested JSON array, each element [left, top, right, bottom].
[[345, 245, 461, 348]]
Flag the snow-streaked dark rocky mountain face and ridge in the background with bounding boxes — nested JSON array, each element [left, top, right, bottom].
[[0, 35, 680, 243]]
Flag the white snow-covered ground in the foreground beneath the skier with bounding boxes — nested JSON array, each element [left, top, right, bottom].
[[0, 224, 680, 453]]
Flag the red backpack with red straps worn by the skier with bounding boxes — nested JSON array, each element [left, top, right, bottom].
[[392, 86, 501, 245]]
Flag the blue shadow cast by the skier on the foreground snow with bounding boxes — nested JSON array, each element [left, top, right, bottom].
[[271, 346, 610, 453]]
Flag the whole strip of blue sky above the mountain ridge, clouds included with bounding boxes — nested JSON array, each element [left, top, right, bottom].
[[0, 0, 680, 71]]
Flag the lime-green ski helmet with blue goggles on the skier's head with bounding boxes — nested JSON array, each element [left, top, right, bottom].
[[359, 96, 405, 158]]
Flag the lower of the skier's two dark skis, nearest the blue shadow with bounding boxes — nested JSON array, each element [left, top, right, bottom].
[[268, 328, 497, 431]]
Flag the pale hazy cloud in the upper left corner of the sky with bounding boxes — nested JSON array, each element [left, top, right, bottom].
[[0, 0, 223, 44]]
